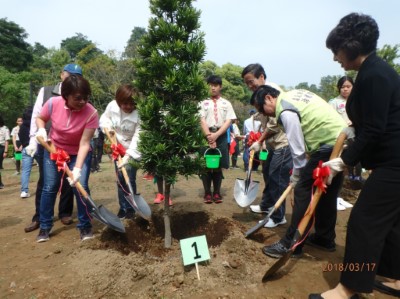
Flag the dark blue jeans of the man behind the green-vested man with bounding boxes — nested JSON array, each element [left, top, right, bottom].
[[260, 146, 293, 222]]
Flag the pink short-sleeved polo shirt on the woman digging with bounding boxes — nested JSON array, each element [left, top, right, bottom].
[[40, 96, 99, 155]]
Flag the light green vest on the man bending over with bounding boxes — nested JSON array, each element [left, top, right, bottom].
[[275, 89, 346, 154]]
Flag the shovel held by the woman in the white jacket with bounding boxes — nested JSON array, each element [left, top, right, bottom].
[[104, 128, 151, 220]]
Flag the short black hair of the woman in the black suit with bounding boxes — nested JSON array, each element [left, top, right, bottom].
[[326, 13, 379, 60]]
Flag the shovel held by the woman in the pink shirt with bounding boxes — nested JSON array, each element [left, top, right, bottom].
[[38, 137, 125, 233]]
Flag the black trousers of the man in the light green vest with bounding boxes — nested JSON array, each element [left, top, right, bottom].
[[281, 149, 343, 247]]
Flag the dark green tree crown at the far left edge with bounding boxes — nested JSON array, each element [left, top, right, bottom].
[[0, 18, 33, 72]]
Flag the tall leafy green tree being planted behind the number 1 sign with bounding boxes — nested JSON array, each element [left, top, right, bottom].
[[135, 0, 207, 248]]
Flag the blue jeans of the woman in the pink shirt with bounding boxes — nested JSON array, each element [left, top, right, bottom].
[[40, 151, 92, 229]]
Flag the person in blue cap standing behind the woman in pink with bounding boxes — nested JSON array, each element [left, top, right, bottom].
[[21, 63, 82, 233]]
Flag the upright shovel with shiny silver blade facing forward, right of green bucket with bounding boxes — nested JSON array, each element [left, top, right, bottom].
[[233, 150, 260, 208]]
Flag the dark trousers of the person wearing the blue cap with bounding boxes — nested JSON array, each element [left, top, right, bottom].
[[32, 145, 74, 221]]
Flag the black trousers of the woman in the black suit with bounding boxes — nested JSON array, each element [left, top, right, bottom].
[[340, 168, 400, 293]]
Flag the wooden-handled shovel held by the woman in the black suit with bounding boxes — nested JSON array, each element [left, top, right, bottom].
[[262, 133, 347, 282]]
